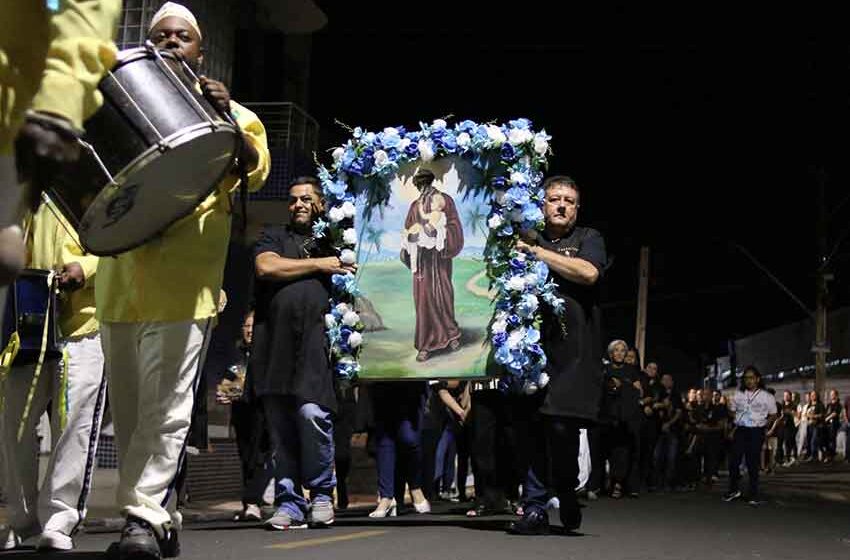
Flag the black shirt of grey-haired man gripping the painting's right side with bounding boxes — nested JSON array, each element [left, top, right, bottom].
[[540, 227, 608, 421]]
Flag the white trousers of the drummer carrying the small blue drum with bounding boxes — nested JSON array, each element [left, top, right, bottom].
[[2, 334, 106, 536]]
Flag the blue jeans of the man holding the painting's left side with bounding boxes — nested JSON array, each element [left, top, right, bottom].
[[263, 395, 336, 521]]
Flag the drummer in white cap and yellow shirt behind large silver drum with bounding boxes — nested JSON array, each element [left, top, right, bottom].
[[95, 2, 269, 559]]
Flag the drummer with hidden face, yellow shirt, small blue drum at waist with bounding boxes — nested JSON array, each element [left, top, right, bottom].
[[0, 204, 106, 550]]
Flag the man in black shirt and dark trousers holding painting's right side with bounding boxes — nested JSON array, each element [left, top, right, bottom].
[[510, 176, 607, 535]]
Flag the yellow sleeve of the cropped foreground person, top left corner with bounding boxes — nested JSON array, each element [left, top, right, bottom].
[[32, 0, 121, 128]]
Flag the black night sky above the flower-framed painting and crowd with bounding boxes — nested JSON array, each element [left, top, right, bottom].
[[309, 1, 850, 381]]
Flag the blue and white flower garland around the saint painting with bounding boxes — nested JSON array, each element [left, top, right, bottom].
[[313, 119, 564, 391]]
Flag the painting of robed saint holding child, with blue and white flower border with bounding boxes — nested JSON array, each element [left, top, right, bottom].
[[314, 119, 562, 380]]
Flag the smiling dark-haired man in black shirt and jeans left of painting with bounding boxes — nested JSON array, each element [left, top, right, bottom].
[[251, 177, 356, 530]]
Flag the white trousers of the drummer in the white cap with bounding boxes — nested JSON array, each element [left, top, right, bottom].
[[101, 319, 212, 536]]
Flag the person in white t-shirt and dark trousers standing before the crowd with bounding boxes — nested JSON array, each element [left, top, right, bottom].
[[723, 366, 776, 505]]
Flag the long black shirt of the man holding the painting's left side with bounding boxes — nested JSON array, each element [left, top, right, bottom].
[[251, 226, 336, 412]]
